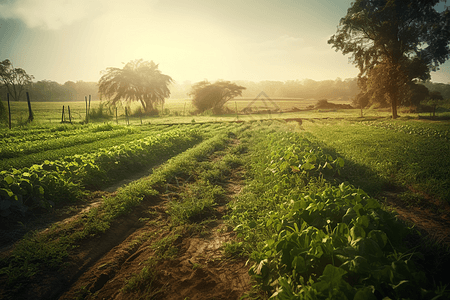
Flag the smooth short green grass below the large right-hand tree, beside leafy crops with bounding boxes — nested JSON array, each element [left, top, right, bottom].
[[302, 120, 450, 202]]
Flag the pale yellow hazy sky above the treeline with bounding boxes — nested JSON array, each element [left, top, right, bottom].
[[0, 0, 450, 83]]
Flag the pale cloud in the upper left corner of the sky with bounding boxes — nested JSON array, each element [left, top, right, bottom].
[[0, 0, 158, 30]]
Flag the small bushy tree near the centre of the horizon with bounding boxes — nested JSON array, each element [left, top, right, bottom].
[[190, 80, 245, 114]]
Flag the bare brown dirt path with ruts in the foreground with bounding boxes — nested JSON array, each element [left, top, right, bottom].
[[58, 156, 251, 299]]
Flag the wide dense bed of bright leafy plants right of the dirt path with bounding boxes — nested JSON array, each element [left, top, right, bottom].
[[230, 123, 448, 299]]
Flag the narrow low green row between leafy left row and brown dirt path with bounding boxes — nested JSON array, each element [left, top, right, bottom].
[[0, 125, 240, 284]]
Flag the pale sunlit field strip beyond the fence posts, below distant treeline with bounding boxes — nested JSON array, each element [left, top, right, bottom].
[[0, 99, 428, 128]]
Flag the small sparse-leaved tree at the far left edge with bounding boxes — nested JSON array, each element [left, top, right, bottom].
[[0, 59, 34, 101]]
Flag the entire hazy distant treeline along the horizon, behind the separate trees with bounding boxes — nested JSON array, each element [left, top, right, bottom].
[[0, 78, 450, 101]]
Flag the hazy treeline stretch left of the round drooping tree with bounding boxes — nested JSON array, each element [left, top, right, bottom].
[[0, 80, 99, 102]]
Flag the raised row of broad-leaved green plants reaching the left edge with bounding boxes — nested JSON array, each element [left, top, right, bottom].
[[0, 129, 201, 216]]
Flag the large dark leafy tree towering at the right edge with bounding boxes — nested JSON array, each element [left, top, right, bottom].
[[328, 0, 450, 118]]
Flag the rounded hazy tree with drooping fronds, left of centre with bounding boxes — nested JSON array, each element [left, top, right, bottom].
[[98, 59, 173, 113]]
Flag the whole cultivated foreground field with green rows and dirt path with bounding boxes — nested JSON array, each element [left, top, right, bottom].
[[0, 109, 450, 299]]
